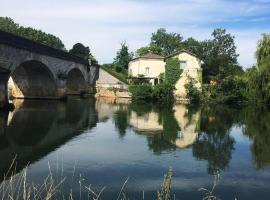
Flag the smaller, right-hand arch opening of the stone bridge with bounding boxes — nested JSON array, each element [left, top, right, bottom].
[[66, 68, 87, 95]]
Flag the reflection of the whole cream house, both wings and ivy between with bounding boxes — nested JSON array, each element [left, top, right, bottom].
[[129, 105, 200, 148]]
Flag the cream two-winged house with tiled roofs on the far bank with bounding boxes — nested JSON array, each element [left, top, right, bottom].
[[128, 49, 202, 99]]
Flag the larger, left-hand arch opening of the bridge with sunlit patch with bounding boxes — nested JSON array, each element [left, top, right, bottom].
[[8, 60, 57, 99]]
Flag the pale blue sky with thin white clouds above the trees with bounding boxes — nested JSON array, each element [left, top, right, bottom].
[[0, 0, 270, 68]]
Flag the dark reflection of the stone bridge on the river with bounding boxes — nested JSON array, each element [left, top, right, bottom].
[[0, 98, 98, 179]]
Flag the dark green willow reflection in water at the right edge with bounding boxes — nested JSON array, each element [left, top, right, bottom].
[[241, 106, 270, 169]]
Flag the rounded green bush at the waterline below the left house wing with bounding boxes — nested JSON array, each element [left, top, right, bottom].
[[128, 84, 153, 100]]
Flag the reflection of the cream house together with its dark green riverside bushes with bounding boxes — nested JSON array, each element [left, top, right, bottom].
[[126, 103, 200, 154]]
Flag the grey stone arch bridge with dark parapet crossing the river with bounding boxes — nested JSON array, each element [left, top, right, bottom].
[[0, 31, 99, 108]]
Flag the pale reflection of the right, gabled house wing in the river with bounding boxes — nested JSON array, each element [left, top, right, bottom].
[[174, 105, 200, 148]]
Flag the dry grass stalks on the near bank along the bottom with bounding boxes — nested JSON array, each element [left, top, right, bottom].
[[0, 158, 220, 200]]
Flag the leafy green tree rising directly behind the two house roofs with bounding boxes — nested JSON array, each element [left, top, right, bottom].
[[150, 28, 183, 56]]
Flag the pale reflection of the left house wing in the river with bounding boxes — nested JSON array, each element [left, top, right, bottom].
[[129, 111, 163, 133]]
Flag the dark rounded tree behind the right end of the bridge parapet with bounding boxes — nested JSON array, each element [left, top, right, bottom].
[[69, 43, 97, 63]]
